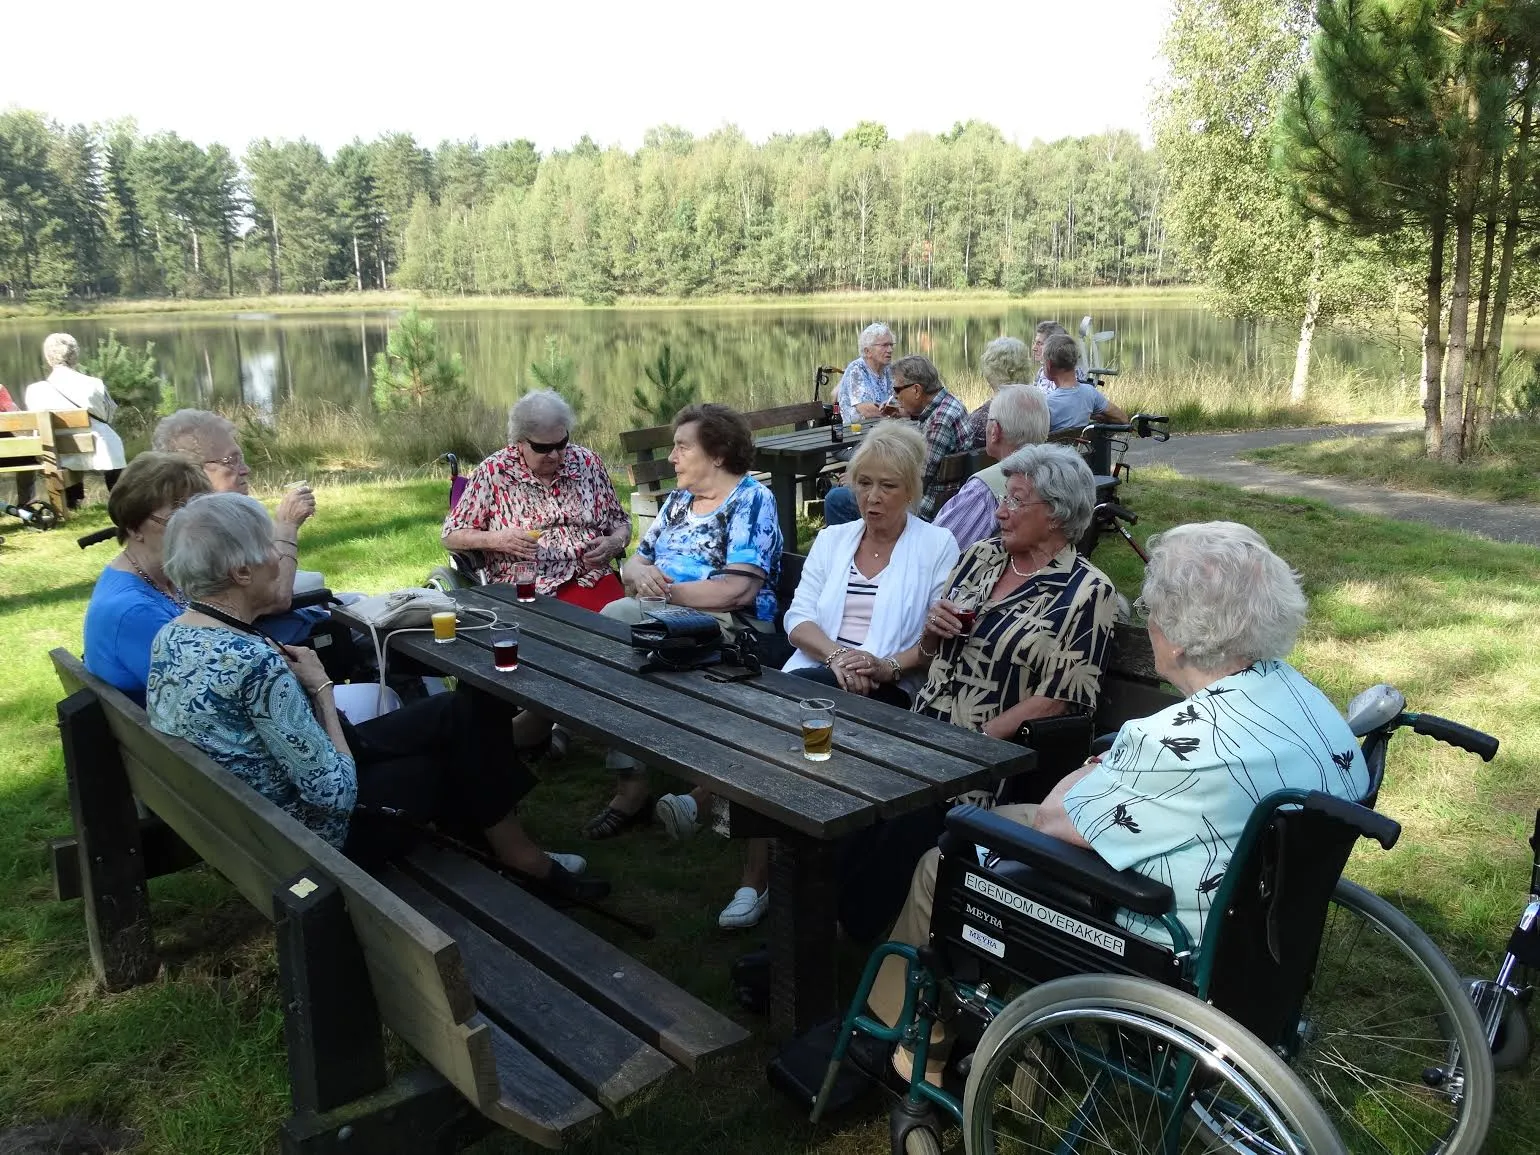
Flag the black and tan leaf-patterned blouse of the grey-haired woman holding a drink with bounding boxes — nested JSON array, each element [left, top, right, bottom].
[[915, 537, 1115, 732]]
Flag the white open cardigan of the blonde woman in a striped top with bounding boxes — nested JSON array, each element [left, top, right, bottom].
[[782, 514, 958, 670]]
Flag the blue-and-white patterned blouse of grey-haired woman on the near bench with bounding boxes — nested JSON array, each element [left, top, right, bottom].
[[146, 622, 359, 849]]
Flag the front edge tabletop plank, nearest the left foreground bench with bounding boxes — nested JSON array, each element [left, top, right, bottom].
[[378, 634, 878, 838]]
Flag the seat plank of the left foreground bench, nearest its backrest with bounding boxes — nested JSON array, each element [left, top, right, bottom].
[[383, 870, 678, 1115]]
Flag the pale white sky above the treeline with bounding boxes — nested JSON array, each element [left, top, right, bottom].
[[0, 0, 1169, 154]]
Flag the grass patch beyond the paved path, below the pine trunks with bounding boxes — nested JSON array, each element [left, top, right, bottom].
[[1241, 420, 1540, 502]]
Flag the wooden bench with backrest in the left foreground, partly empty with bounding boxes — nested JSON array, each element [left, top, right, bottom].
[[51, 650, 748, 1155]]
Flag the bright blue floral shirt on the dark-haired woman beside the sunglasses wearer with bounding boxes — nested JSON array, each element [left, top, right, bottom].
[[636, 477, 781, 622]]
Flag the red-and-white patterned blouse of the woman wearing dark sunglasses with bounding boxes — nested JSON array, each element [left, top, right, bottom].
[[444, 445, 630, 593]]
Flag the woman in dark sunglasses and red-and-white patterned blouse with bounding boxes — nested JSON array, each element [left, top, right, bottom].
[[444, 390, 631, 611]]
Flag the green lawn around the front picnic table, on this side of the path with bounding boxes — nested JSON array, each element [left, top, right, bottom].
[[0, 468, 1540, 1155]]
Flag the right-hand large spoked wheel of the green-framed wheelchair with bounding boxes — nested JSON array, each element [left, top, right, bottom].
[[1292, 879, 1495, 1155]]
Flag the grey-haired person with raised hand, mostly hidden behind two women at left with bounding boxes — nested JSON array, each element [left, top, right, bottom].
[[149, 410, 326, 642]]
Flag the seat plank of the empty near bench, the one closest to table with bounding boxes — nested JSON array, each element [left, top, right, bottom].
[[405, 847, 748, 1070]]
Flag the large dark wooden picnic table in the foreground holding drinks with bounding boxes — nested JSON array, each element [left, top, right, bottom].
[[336, 591, 1036, 1032]]
